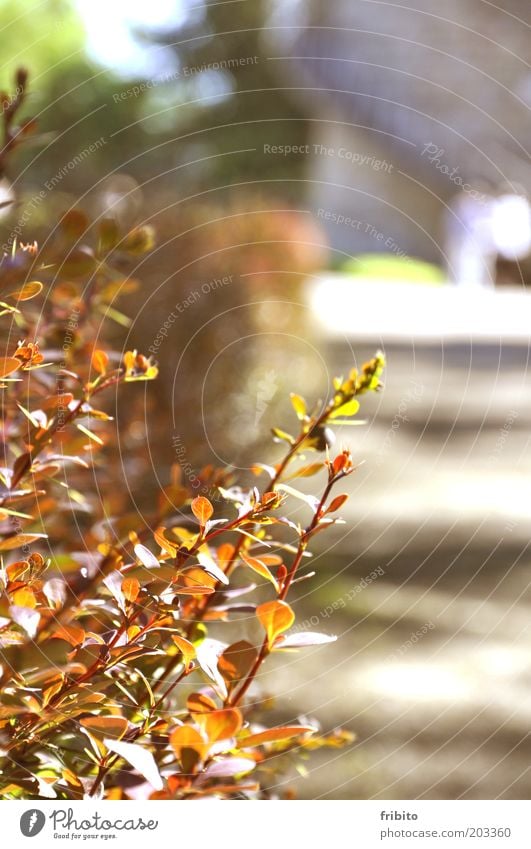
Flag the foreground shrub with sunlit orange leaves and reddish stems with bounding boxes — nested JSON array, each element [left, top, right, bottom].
[[0, 69, 384, 799]]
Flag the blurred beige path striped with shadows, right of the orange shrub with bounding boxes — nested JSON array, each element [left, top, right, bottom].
[[272, 290, 531, 799]]
